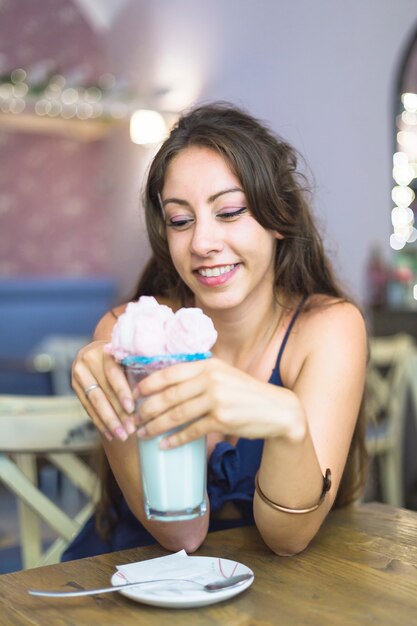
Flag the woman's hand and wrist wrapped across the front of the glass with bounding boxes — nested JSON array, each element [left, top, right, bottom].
[[137, 358, 306, 448]]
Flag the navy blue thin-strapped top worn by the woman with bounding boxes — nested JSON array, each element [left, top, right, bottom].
[[61, 298, 305, 561]]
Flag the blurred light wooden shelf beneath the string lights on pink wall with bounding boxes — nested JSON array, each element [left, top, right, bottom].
[[0, 113, 123, 143]]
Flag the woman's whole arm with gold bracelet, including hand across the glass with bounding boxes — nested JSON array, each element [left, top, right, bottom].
[[135, 303, 367, 555]]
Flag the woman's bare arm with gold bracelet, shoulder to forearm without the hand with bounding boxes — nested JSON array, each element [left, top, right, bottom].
[[254, 303, 367, 554]]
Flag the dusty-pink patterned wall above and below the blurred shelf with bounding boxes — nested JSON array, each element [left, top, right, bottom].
[[0, 0, 110, 277]]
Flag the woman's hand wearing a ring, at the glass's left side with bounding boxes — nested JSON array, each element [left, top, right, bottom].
[[72, 340, 137, 441]]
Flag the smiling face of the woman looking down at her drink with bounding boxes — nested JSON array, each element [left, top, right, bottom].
[[161, 147, 281, 310]]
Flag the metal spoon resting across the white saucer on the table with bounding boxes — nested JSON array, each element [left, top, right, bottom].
[[28, 574, 253, 598]]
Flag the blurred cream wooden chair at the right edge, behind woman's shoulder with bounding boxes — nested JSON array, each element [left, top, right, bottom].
[[365, 334, 417, 506]]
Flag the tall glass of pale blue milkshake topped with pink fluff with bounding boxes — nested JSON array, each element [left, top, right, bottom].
[[106, 296, 217, 521]]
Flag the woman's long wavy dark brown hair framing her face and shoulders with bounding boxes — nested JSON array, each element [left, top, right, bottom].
[[96, 103, 366, 536]]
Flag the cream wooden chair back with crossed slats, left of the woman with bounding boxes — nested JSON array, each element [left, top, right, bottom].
[[0, 395, 99, 569]]
